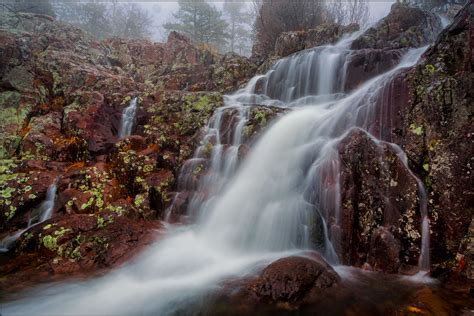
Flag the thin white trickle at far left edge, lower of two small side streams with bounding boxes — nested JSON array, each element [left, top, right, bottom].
[[0, 180, 57, 252]]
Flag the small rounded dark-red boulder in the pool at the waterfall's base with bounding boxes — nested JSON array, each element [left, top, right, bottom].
[[248, 253, 340, 306]]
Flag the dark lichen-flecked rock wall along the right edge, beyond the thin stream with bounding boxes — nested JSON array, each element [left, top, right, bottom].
[[397, 3, 474, 278]]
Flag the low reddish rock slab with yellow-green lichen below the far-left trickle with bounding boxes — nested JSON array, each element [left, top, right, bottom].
[[0, 208, 161, 291]]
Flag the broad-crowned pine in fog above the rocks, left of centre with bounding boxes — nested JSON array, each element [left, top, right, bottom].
[[163, 0, 228, 48]]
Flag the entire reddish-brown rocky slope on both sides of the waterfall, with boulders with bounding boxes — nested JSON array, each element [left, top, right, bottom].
[[0, 4, 474, 306]]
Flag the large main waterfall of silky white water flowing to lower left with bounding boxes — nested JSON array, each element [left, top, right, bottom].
[[4, 35, 432, 315]]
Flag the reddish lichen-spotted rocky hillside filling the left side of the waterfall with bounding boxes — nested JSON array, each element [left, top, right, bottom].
[[0, 13, 256, 288]]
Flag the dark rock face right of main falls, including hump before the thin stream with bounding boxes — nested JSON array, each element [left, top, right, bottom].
[[332, 4, 474, 277]]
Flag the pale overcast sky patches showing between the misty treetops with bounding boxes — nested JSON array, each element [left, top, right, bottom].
[[136, 0, 395, 42]]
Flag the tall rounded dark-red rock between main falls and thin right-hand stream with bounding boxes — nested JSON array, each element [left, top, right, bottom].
[[336, 129, 421, 273]]
